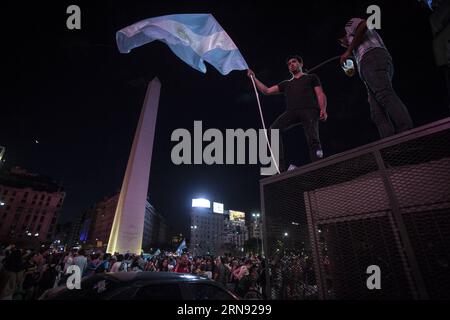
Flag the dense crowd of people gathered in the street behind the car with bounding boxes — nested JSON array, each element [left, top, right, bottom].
[[0, 245, 266, 300]]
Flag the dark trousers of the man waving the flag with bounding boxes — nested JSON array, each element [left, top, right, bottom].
[[269, 108, 323, 171]]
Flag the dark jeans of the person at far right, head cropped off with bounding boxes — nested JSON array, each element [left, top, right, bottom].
[[360, 48, 413, 138]]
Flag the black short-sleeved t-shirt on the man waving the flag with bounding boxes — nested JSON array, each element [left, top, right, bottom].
[[278, 74, 321, 110]]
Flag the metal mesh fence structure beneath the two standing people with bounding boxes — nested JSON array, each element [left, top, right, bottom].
[[261, 118, 450, 299]]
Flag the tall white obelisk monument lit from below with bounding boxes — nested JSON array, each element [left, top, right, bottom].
[[107, 78, 161, 254]]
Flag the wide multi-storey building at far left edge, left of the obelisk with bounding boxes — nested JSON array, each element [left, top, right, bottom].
[[0, 167, 66, 245]]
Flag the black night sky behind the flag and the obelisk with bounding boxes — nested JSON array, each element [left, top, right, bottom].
[[0, 0, 448, 232]]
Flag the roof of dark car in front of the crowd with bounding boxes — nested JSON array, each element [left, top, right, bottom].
[[40, 271, 239, 300]]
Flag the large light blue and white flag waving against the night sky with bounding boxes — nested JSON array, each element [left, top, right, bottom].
[[116, 14, 248, 75]]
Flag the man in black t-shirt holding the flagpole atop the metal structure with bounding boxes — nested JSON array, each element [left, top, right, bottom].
[[247, 55, 327, 171]]
